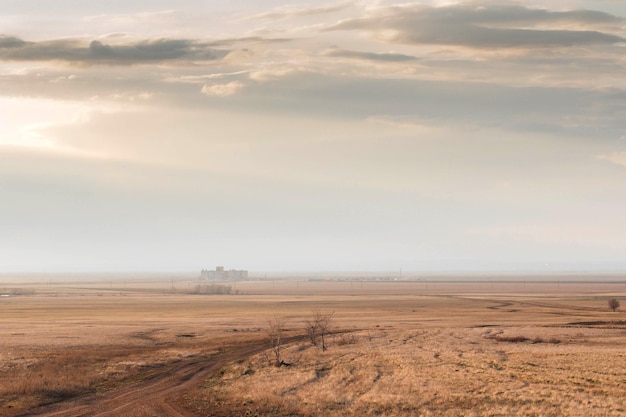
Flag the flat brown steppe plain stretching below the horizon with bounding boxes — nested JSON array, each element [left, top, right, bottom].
[[0, 276, 626, 417]]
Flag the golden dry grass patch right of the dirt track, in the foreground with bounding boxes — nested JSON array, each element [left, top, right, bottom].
[[199, 328, 626, 416]]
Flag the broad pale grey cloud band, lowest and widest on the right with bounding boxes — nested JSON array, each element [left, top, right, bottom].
[[217, 68, 625, 137]]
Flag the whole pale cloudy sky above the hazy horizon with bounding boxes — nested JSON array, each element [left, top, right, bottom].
[[0, 0, 626, 272]]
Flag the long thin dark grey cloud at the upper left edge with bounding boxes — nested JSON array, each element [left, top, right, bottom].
[[0, 37, 229, 65]]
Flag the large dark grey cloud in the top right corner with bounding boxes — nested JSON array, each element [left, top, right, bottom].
[[328, 4, 624, 48]]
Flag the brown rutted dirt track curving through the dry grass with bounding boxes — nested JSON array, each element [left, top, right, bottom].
[[13, 338, 282, 417]]
